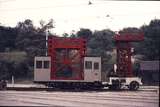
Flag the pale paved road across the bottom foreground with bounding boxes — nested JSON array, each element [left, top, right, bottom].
[[0, 90, 159, 107]]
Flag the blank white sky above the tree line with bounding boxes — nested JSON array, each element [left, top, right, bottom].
[[0, 0, 160, 35]]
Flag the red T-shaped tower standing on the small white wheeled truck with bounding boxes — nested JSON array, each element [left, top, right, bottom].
[[114, 33, 144, 77]]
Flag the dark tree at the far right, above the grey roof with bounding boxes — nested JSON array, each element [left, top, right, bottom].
[[137, 19, 160, 60]]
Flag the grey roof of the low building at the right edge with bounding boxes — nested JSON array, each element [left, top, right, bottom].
[[140, 61, 159, 71]]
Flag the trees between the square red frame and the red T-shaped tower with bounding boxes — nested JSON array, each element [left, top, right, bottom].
[[87, 29, 115, 71]]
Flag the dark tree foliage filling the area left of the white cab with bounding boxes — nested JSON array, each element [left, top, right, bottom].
[[0, 19, 53, 77]]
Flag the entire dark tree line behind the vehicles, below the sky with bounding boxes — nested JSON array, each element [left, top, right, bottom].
[[0, 19, 160, 78]]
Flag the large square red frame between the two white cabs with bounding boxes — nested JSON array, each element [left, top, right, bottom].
[[48, 36, 86, 80]]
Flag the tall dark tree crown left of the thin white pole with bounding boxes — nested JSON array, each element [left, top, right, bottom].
[[16, 19, 49, 58]]
